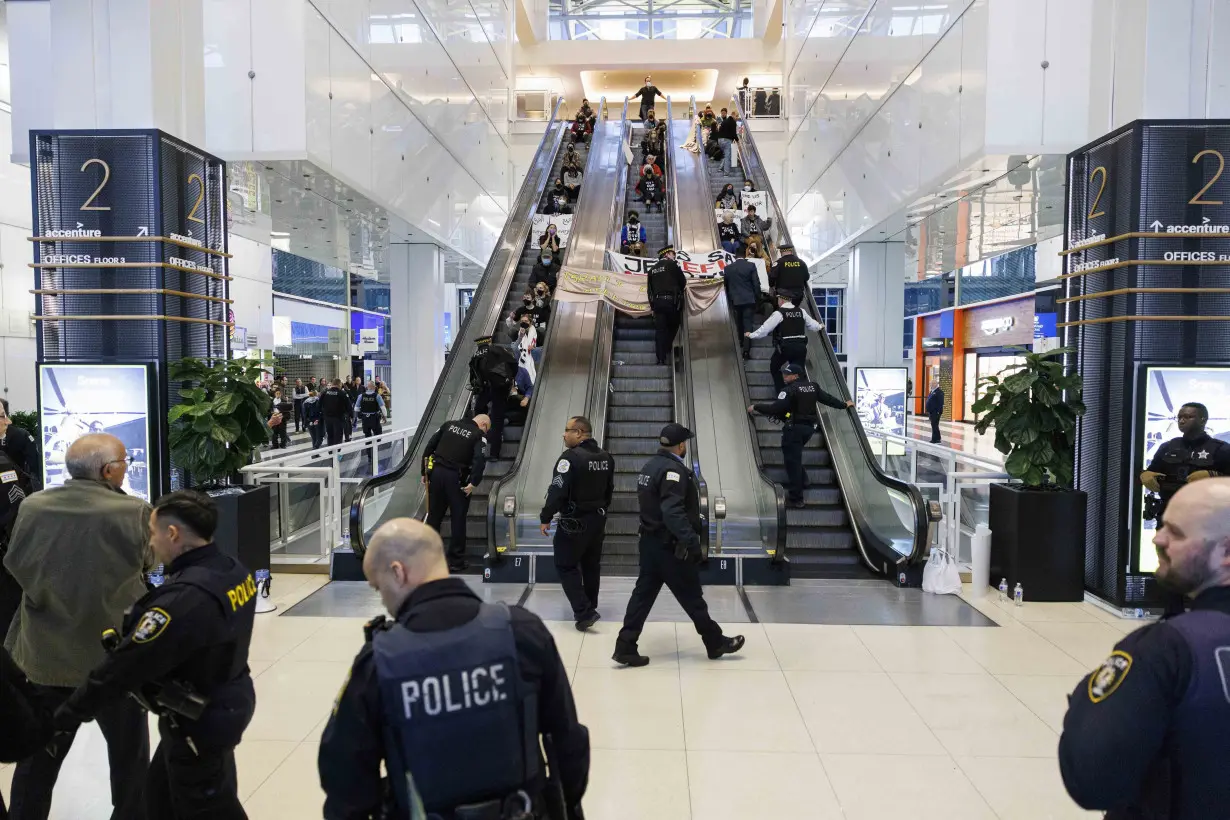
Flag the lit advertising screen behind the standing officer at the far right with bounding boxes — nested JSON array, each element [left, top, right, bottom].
[[1133, 368, 1230, 573]]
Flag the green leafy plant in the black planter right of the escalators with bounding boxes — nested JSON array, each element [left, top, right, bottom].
[[973, 348, 1085, 488]]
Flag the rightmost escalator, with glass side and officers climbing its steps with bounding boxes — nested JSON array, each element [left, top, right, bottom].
[[710, 100, 929, 579]]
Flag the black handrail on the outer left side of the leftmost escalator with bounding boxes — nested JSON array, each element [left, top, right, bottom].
[[349, 96, 566, 557]]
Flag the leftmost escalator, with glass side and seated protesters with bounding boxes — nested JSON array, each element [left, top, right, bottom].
[[346, 98, 568, 565]]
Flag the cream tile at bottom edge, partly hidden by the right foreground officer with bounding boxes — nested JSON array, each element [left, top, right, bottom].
[[957, 757, 1102, 820]]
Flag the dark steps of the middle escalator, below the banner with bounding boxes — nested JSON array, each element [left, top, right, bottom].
[[603, 118, 675, 575]]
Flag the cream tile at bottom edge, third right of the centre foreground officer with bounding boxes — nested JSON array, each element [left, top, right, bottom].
[[820, 755, 995, 820]]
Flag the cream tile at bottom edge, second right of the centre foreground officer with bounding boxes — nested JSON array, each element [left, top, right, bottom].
[[688, 751, 841, 820]]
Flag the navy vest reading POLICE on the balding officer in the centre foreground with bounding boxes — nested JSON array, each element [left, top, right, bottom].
[[371, 604, 539, 816]]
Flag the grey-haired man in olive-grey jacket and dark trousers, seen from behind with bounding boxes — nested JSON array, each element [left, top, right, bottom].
[[4, 434, 150, 820]]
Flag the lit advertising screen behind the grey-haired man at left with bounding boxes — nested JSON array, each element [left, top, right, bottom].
[[38, 364, 150, 500]]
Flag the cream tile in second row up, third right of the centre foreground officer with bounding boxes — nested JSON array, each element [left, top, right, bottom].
[[786, 671, 947, 755]]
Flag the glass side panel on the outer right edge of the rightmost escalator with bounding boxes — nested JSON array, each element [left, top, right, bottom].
[[733, 95, 927, 574]]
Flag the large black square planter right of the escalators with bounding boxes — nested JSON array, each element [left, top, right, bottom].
[[990, 484, 1087, 604]]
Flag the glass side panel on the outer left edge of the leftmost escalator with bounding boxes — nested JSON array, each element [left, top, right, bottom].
[[349, 97, 567, 554]]
